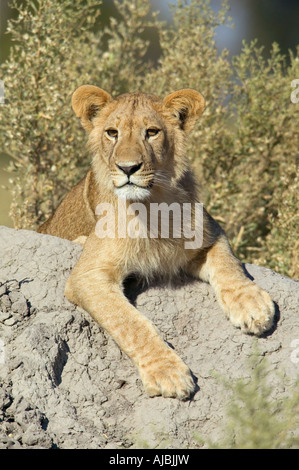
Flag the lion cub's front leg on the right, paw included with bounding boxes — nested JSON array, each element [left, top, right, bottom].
[[192, 235, 274, 335]]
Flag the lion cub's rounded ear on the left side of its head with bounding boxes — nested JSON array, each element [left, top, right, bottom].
[[72, 85, 112, 132]]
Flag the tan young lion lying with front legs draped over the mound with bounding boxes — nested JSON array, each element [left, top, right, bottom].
[[39, 85, 274, 399]]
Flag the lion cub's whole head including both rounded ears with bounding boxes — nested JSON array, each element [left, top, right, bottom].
[[72, 85, 204, 201]]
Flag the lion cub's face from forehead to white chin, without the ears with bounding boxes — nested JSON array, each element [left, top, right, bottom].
[[98, 94, 172, 200]]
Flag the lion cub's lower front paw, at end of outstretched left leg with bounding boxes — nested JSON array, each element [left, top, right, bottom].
[[139, 349, 195, 400]]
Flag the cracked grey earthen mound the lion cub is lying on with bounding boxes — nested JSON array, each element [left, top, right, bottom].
[[0, 227, 299, 449]]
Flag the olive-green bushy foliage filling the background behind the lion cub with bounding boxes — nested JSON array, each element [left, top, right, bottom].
[[0, 0, 299, 277]]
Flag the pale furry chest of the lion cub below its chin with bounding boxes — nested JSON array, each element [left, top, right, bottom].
[[95, 202, 200, 279]]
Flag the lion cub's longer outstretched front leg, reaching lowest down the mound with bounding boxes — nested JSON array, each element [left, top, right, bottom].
[[65, 242, 195, 399]]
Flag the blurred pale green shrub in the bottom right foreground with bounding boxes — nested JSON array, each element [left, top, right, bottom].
[[208, 348, 299, 449]]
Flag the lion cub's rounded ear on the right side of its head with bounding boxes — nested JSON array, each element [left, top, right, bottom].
[[163, 88, 205, 132]]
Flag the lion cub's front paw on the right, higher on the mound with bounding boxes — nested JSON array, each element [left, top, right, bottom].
[[222, 281, 275, 335]]
